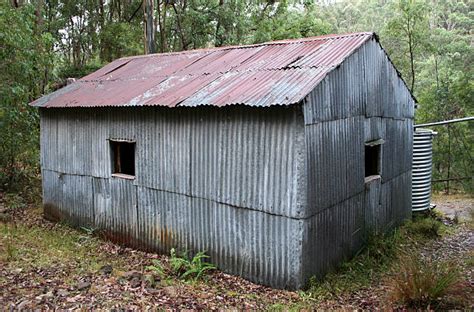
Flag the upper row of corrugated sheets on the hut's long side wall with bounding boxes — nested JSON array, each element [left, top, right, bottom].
[[41, 107, 305, 217]]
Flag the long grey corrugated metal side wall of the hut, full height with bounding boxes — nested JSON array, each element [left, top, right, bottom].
[[41, 106, 306, 288]]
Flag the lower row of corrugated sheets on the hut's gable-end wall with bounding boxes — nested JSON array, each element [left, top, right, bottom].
[[303, 171, 411, 283]]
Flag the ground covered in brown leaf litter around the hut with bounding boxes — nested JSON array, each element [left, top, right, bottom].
[[0, 194, 474, 310]]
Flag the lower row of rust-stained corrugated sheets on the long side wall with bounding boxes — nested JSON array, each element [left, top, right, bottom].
[[43, 170, 304, 289]]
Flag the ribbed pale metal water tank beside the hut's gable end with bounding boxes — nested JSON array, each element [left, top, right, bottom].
[[412, 129, 437, 211]]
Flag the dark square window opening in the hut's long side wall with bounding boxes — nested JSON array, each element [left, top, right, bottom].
[[110, 140, 135, 176]]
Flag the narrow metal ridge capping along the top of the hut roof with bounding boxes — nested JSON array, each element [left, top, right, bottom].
[[120, 32, 378, 61]]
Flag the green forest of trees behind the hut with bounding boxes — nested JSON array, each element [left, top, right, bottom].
[[0, 0, 474, 194]]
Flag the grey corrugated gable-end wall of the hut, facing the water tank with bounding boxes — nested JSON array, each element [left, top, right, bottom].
[[303, 40, 414, 279]]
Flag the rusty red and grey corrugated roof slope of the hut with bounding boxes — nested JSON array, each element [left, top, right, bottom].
[[32, 32, 375, 107]]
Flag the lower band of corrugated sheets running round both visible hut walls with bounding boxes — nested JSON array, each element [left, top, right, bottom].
[[39, 166, 411, 289]]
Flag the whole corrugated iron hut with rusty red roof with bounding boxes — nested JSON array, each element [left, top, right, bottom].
[[33, 33, 414, 289]]
